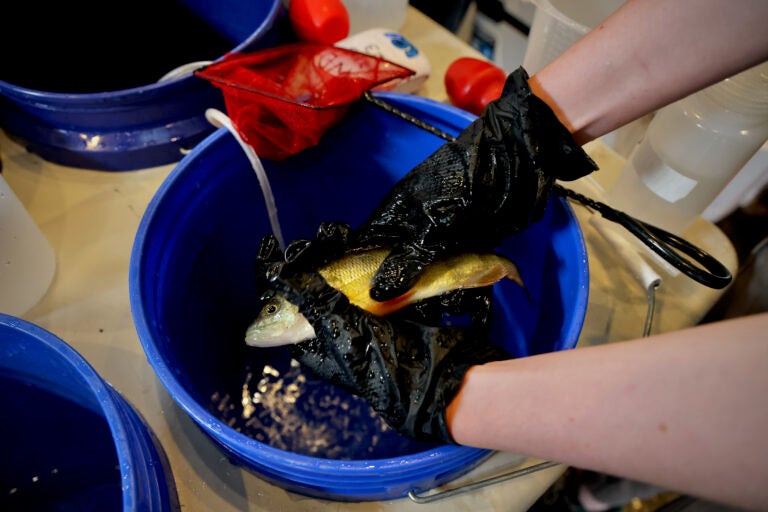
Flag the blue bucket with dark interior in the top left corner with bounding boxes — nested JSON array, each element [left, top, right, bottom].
[[0, 0, 284, 171]]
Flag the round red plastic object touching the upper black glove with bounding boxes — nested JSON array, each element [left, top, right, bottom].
[[445, 57, 507, 116]]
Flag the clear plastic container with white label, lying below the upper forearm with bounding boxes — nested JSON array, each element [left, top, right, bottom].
[[609, 62, 768, 234]]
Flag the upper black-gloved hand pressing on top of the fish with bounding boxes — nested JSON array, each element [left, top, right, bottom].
[[353, 68, 597, 301]]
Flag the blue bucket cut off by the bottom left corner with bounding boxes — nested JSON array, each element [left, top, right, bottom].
[[0, 313, 180, 512]]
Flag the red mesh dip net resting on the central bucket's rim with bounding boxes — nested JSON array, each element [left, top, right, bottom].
[[195, 42, 414, 161]]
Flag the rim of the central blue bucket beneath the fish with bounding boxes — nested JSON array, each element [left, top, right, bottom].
[[129, 92, 589, 492]]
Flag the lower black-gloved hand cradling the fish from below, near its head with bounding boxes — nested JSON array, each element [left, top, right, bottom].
[[256, 223, 511, 443]]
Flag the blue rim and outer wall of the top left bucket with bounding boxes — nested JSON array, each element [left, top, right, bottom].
[[0, 0, 284, 171]]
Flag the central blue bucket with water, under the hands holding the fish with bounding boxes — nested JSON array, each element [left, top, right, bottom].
[[129, 93, 589, 501]]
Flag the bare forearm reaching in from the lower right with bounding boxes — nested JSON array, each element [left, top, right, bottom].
[[447, 314, 768, 507]]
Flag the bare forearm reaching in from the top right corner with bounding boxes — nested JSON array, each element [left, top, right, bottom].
[[530, 0, 768, 144]]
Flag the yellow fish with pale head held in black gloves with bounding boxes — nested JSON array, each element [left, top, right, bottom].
[[245, 249, 523, 347]]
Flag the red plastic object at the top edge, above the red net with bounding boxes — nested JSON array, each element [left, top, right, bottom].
[[288, 0, 349, 44]]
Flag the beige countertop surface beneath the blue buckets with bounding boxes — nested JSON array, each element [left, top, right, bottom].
[[0, 7, 737, 512]]
